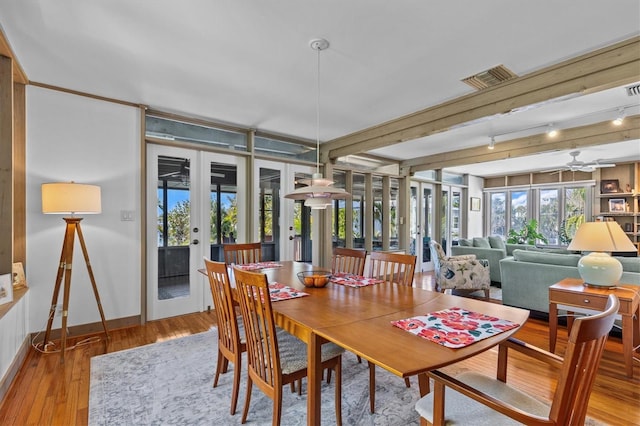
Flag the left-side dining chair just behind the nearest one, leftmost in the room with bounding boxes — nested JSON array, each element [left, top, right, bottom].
[[204, 258, 247, 415]]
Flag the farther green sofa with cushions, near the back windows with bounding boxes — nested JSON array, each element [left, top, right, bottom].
[[451, 236, 548, 283]]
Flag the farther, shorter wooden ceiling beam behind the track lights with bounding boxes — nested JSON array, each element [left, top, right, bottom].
[[400, 115, 640, 174]]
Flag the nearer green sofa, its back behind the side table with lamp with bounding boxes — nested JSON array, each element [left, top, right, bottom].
[[500, 250, 640, 313]]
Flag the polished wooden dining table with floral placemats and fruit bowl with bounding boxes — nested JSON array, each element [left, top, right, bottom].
[[225, 262, 529, 425]]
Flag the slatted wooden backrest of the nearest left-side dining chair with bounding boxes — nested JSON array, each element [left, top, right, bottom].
[[233, 268, 282, 398]]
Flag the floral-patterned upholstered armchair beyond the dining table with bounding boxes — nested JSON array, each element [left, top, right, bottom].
[[429, 240, 491, 300]]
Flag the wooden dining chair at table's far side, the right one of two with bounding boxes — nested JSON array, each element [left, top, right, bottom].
[[369, 251, 416, 413]]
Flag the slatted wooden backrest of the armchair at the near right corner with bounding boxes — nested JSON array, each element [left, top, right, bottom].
[[549, 294, 619, 425]]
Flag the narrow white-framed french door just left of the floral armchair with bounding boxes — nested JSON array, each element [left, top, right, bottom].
[[410, 181, 433, 272]]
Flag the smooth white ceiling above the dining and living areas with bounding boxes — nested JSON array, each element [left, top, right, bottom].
[[0, 0, 640, 176]]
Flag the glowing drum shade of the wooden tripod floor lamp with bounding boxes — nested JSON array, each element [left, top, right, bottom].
[[42, 182, 102, 214]]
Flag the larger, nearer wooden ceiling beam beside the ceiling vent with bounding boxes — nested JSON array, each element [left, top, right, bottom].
[[320, 37, 640, 159]]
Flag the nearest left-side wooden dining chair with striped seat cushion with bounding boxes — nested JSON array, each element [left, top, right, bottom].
[[234, 267, 344, 425]]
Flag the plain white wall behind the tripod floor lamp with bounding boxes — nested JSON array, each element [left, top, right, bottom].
[[26, 86, 141, 331]]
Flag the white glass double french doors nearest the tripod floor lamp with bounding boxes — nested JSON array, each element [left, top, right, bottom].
[[147, 144, 246, 320]]
